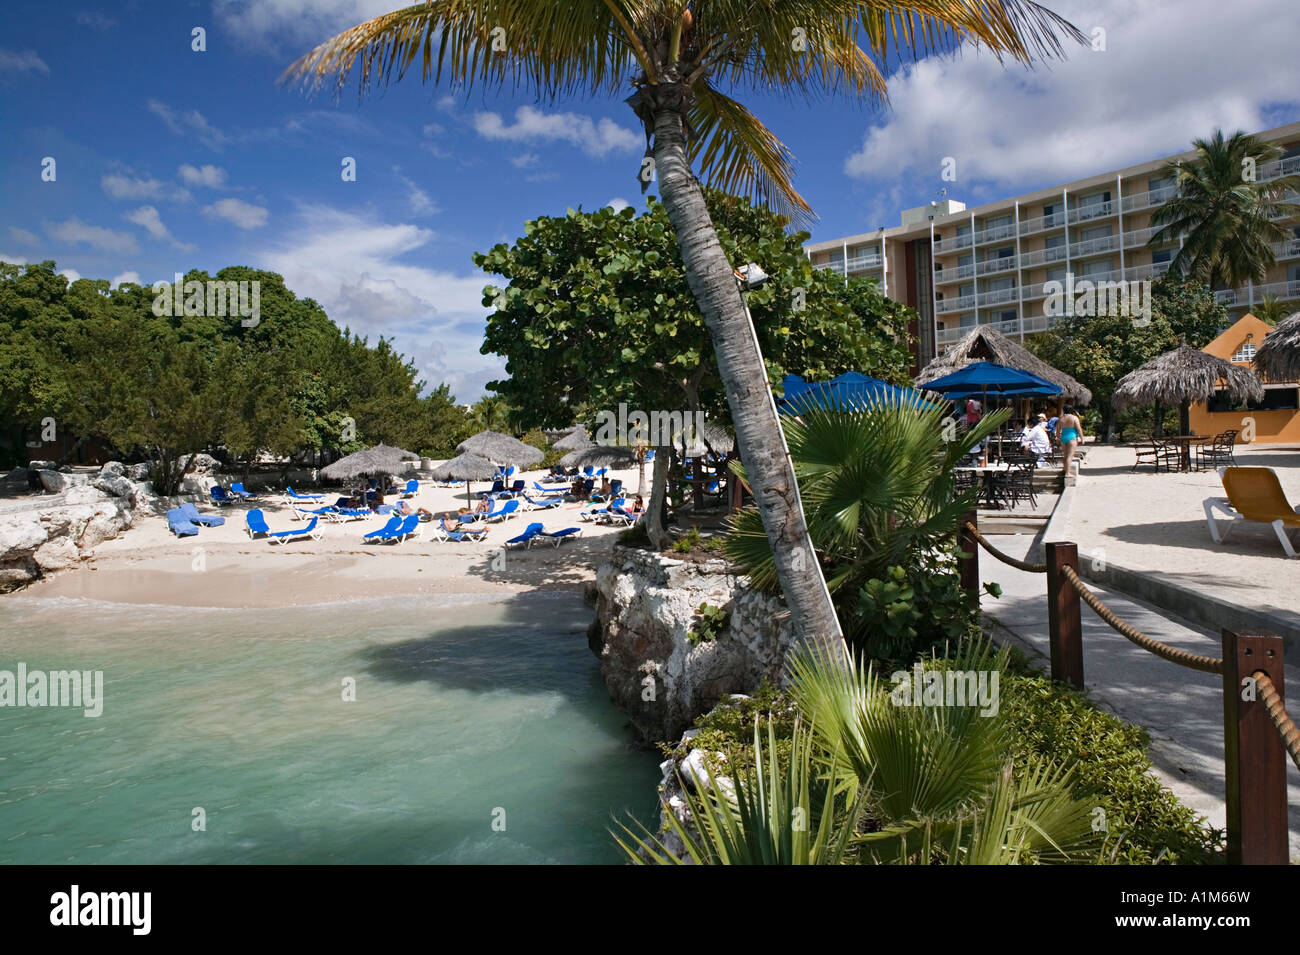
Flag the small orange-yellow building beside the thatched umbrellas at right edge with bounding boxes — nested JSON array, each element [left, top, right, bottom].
[[1190, 312, 1300, 443]]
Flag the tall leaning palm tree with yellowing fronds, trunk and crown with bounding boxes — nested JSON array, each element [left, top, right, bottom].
[[286, 0, 1083, 660]]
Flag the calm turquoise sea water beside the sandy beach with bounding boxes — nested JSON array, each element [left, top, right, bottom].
[[0, 594, 658, 863]]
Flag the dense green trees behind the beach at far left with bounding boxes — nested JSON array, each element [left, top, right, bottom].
[[0, 261, 471, 485]]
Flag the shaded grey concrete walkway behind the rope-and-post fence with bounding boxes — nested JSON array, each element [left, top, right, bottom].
[[979, 534, 1300, 863]]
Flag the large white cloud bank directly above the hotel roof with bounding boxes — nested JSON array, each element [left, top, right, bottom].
[[844, 0, 1300, 216]]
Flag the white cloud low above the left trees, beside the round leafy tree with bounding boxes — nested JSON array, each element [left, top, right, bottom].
[[255, 205, 504, 401]]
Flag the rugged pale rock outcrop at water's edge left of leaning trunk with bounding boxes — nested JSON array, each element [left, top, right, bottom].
[[590, 547, 792, 742]]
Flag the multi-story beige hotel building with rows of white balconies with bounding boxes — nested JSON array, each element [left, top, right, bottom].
[[806, 122, 1300, 366]]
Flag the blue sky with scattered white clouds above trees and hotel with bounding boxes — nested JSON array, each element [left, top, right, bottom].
[[0, 0, 1300, 401]]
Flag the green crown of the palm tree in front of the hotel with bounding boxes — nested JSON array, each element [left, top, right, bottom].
[[1147, 130, 1300, 288]]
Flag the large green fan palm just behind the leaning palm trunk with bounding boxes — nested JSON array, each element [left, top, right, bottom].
[[727, 395, 1010, 656]]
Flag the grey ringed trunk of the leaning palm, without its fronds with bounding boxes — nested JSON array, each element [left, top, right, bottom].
[[654, 103, 844, 659]]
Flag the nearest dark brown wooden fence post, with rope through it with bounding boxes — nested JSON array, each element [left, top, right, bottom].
[[1223, 629, 1288, 865]]
